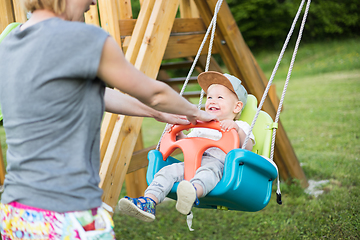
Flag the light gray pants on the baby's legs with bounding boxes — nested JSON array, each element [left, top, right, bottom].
[[145, 155, 224, 203]]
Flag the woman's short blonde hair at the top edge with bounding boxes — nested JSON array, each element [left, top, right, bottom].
[[22, 0, 66, 15]]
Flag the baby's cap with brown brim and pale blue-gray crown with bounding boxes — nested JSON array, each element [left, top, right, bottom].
[[198, 71, 247, 106]]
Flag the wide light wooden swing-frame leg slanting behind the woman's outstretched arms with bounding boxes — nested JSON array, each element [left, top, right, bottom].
[[100, 0, 179, 210]]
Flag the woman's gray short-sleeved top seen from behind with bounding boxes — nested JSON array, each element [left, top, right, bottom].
[[0, 18, 108, 212]]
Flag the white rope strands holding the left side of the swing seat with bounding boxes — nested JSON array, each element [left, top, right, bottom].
[[156, 0, 223, 150]]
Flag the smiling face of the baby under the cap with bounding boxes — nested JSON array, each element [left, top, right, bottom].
[[205, 84, 239, 121]]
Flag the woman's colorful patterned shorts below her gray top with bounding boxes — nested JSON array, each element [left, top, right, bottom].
[[0, 202, 115, 240]]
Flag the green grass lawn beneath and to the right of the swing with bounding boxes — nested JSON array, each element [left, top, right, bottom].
[[0, 39, 360, 239]]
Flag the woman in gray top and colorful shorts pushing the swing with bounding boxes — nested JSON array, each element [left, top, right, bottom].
[[0, 0, 216, 239]]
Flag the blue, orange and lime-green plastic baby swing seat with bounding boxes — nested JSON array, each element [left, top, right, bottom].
[[147, 94, 278, 212]]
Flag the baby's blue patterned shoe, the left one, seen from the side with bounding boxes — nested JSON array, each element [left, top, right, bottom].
[[119, 196, 156, 222]]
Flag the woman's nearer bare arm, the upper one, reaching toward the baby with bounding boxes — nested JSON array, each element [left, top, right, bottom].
[[98, 37, 216, 124]]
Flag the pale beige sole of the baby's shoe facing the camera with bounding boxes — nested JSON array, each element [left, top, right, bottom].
[[176, 181, 196, 215]]
